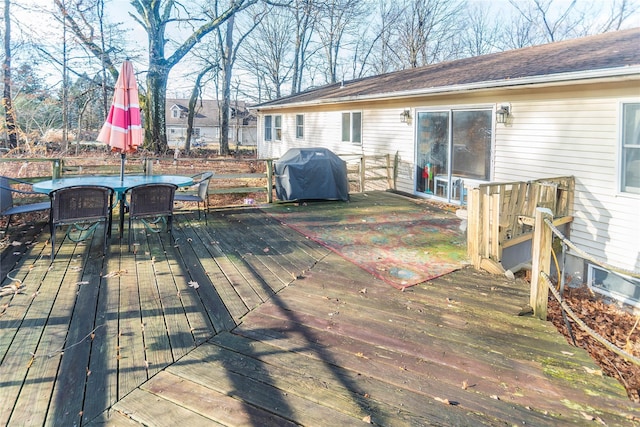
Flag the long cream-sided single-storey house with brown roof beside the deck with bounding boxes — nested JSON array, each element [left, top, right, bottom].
[[254, 28, 640, 308]]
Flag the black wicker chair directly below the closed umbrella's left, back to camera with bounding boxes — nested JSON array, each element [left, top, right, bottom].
[[49, 185, 113, 262]]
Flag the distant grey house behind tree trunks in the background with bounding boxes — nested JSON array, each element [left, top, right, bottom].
[[166, 99, 257, 148]]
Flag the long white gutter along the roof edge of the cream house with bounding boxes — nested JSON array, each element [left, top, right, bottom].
[[256, 65, 640, 111]]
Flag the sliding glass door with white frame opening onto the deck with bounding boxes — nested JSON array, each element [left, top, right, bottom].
[[416, 109, 492, 203]]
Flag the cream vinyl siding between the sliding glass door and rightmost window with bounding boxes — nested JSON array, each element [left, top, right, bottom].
[[494, 91, 640, 270]]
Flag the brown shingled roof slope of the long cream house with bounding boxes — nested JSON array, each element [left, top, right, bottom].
[[256, 28, 640, 108]]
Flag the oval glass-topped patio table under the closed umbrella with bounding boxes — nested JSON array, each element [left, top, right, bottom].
[[33, 175, 193, 238]]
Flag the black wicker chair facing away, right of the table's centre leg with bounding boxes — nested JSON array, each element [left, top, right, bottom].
[[126, 184, 178, 251]]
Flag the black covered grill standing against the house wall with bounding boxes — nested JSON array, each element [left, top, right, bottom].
[[274, 148, 349, 201]]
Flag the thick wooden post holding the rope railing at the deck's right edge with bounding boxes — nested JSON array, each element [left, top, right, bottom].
[[529, 208, 553, 320]]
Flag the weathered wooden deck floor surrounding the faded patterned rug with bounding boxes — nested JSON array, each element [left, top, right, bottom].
[[0, 193, 640, 426]]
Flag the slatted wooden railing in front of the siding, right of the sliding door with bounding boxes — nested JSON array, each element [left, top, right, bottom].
[[467, 176, 575, 273]]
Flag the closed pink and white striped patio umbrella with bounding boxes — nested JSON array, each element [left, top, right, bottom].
[[97, 60, 142, 180]]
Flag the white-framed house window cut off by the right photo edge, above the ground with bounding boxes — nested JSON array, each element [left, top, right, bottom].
[[620, 103, 640, 194]]
